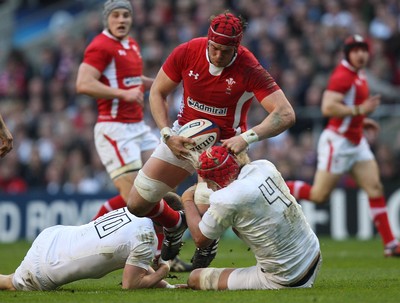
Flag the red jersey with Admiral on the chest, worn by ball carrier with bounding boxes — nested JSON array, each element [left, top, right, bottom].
[[162, 38, 280, 139]]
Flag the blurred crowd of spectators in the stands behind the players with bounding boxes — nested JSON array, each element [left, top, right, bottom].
[[0, 0, 400, 194]]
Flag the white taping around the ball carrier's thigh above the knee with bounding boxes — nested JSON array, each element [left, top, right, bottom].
[[134, 170, 172, 203]]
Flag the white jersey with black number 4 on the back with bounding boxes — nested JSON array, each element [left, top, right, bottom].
[[199, 160, 320, 285]]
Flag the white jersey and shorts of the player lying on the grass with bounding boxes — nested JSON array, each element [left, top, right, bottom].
[[13, 207, 157, 290]]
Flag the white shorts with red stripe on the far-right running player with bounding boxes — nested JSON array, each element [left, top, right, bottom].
[[318, 129, 375, 174]]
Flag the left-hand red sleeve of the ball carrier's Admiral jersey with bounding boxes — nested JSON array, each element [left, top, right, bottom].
[[162, 43, 188, 83]]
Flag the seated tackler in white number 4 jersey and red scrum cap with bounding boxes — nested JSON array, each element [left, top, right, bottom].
[[182, 146, 322, 290]]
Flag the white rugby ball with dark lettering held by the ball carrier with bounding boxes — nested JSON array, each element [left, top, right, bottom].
[[178, 119, 220, 152]]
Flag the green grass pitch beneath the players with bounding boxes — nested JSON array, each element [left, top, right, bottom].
[[0, 238, 400, 303]]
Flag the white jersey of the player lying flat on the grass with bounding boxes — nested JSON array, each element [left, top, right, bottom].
[[45, 207, 157, 285]]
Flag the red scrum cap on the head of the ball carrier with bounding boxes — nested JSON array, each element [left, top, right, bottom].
[[208, 13, 244, 47]]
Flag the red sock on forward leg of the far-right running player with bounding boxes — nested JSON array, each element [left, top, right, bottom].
[[369, 197, 394, 245]]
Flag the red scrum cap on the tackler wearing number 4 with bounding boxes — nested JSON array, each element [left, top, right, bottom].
[[197, 146, 240, 188]]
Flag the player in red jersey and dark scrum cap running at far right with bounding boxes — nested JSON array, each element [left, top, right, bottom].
[[287, 35, 400, 257]]
